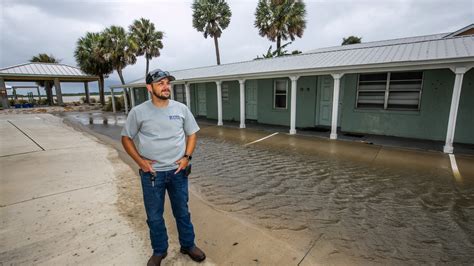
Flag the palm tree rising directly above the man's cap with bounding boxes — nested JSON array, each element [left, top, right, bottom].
[[128, 18, 163, 76]]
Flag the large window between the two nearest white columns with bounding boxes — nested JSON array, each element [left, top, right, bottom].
[[357, 72, 423, 110]]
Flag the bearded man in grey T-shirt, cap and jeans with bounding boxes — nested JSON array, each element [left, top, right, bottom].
[[122, 69, 206, 265]]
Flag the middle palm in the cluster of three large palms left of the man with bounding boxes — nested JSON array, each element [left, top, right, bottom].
[[103, 26, 138, 84]]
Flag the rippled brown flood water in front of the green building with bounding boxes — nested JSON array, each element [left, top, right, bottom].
[[64, 113, 474, 265]]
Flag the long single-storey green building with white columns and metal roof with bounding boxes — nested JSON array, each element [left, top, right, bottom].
[[112, 24, 474, 153]]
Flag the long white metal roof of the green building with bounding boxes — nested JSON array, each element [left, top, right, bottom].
[[112, 35, 474, 87]]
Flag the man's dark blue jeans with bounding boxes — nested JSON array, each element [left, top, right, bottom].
[[139, 167, 194, 256]]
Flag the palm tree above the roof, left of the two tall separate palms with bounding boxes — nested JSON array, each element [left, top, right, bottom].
[[192, 0, 232, 65]]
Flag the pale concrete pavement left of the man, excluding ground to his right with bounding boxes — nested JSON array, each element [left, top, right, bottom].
[[0, 115, 147, 265]]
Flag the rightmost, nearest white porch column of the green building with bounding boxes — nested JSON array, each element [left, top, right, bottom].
[[443, 67, 467, 153]]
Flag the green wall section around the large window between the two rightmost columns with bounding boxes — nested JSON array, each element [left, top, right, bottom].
[[341, 69, 462, 140]]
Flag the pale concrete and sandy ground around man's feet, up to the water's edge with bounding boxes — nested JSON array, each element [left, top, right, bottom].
[[0, 114, 314, 265]]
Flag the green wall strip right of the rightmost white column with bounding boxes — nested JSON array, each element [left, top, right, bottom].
[[454, 69, 474, 144]]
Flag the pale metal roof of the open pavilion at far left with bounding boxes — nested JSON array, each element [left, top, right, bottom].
[[0, 63, 95, 77]]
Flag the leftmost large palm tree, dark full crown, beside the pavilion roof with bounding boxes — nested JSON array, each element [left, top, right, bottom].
[[74, 32, 113, 106]]
